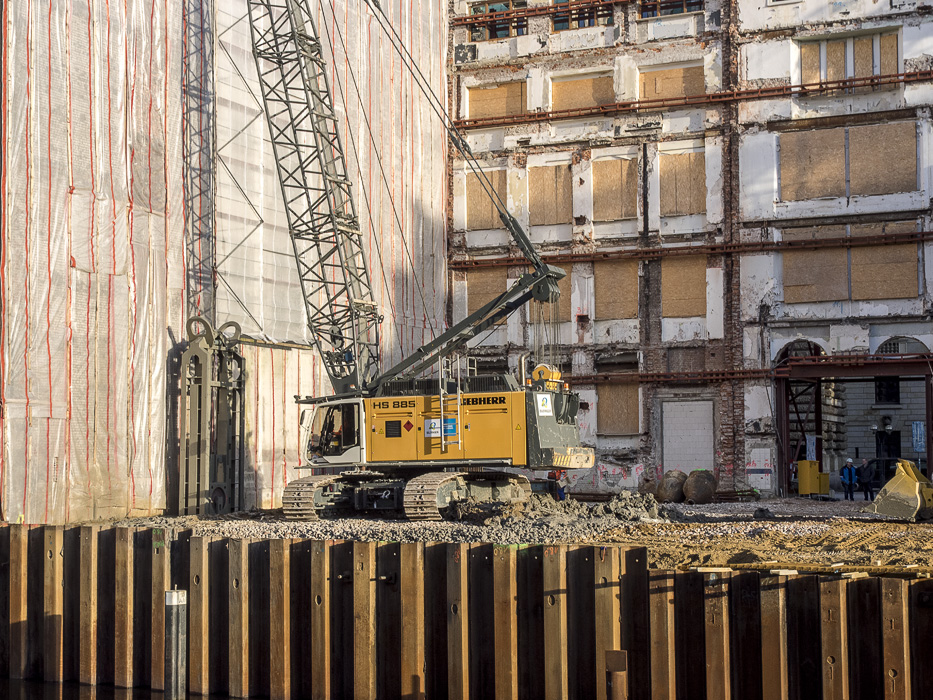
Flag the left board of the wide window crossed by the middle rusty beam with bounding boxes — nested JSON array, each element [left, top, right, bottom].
[[782, 226, 849, 304]]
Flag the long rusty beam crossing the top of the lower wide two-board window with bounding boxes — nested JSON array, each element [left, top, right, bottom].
[[448, 231, 933, 270]]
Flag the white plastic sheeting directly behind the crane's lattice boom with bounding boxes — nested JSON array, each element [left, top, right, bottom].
[[206, 0, 447, 507]]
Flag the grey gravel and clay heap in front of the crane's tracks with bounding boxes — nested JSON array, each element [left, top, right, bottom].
[[116, 492, 668, 544]]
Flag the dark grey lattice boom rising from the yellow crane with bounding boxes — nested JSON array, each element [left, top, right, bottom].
[[248, 0, 382, 394]]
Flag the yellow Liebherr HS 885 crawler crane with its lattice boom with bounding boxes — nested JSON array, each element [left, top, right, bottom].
[[248, 0, 594, 520]]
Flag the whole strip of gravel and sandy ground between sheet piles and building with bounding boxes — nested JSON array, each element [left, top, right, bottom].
[[111, 492, 933, 568]]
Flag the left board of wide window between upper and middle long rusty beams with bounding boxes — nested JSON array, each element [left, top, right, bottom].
[[781, 129, 846, 202]]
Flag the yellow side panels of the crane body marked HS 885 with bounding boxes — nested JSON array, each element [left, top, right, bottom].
[[364, 391, 528, 467]]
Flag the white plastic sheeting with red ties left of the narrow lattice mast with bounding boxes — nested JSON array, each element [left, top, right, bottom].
[[0, 0, 184, 522]]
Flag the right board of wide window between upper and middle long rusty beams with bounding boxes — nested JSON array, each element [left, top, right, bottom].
[[849, 122, 917, 195]]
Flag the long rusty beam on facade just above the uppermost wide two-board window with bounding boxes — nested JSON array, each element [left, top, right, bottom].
[[454, 70, 933, 129]]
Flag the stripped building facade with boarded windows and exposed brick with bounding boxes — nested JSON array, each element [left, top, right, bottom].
[[448, 0, 933, 493]]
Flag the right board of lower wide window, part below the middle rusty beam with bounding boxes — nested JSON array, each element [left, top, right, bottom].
[[852, 243, 920, 299]]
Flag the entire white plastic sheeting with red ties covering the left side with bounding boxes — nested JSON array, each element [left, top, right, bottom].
[[0, 0, 447, 523]]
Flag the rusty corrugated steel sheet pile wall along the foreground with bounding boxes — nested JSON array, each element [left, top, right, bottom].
[[0, 526, 933, 700]]
